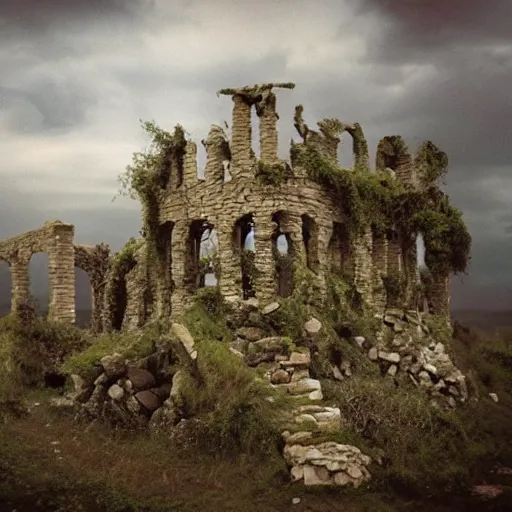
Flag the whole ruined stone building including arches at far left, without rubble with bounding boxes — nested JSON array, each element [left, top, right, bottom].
[[0, 84, 456, 331]]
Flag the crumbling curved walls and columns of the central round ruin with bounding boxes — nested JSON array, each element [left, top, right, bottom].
[[151, 84, 452, 314]]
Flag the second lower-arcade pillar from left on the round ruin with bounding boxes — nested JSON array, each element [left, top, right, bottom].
[[217, 222, 242, 301]]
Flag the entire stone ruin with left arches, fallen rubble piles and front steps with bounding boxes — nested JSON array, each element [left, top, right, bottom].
[[0, 84, 468, 487]]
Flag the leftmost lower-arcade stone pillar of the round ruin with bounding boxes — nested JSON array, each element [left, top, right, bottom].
[[171, 220, 189, 319]]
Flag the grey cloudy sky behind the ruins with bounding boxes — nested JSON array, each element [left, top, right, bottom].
[[0, 0, 512, 308]]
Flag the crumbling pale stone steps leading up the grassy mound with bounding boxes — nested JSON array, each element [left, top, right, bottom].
[[245, 337, 371, 487]]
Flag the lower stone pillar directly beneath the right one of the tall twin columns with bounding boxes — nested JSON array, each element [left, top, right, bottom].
[[254, 215, 276, 303]]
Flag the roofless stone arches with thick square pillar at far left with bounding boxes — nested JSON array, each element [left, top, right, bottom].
[[0, 221, 75, 323]]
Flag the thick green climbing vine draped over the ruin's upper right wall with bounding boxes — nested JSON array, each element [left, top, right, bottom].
[[291, 140, 471, 275]]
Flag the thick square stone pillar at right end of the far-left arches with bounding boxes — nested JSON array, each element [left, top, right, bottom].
[[47, 223, 75, 323]]
